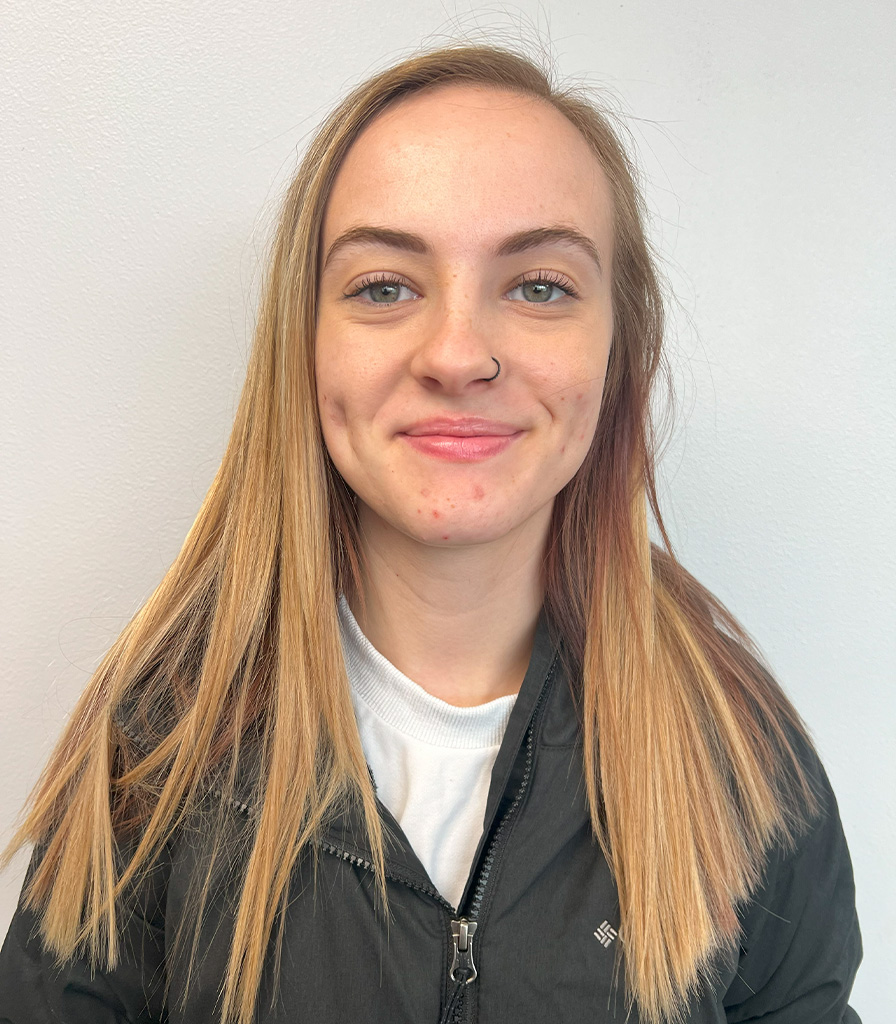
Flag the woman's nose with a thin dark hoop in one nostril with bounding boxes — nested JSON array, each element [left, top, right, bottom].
[[411, 304, 500, 395]]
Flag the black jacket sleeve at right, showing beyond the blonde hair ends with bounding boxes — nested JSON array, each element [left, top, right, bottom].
[[724, 756, 862, 1024]]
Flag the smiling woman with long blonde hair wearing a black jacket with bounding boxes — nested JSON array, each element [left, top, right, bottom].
[[0, 47, 860, 1024]]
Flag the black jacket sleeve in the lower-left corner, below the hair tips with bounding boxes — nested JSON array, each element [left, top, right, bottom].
[[0, 847, 168, 1024]]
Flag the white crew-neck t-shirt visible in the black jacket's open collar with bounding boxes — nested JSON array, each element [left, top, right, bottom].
[[339, 597, 516, 907]]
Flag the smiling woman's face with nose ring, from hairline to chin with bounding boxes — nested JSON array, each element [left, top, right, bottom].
[[315, 85, 612, 546]]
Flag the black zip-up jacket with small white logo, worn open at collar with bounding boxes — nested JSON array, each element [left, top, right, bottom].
[[0, 623, 861, 1024]]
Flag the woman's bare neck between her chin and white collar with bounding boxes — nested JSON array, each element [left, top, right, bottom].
[[349, 510, 550, 708]]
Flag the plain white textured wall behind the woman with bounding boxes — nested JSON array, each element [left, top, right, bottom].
[[0, 0, 896, 1024]]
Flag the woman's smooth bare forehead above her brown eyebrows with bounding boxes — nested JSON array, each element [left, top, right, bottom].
[[324, 84, 612, 260]]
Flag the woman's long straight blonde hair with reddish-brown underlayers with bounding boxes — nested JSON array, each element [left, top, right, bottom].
[[7, 45, 813, 1024]]
